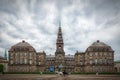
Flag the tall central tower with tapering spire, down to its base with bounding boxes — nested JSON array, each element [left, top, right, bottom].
[[55, 22, 65, 71]]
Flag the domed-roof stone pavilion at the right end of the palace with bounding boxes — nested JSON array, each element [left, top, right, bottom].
[[85, 40, 114, 72]]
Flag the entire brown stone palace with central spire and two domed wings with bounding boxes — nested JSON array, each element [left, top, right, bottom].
[[8, 25, 114, 72]]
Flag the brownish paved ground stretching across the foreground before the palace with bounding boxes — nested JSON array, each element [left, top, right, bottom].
[[0, 74, 120, 80]]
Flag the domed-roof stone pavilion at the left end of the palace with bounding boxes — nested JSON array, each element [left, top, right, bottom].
[[9, 41, 36, 72]]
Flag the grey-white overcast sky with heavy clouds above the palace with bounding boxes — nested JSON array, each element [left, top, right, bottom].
[[0, 0, 120, 60]]
